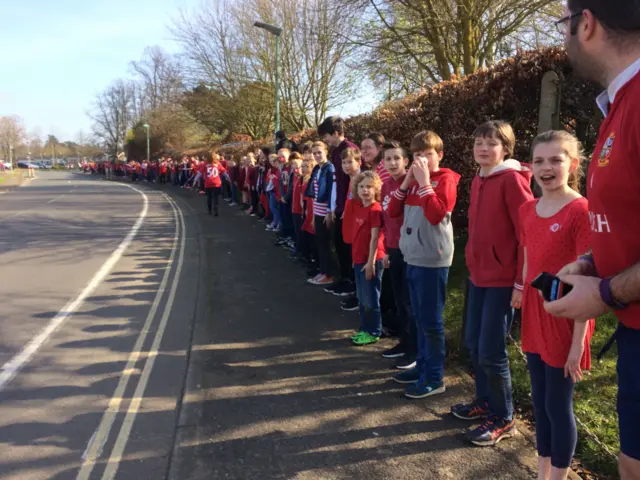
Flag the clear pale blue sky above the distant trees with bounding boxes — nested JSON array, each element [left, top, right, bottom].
[[0, 0, 374, 141]]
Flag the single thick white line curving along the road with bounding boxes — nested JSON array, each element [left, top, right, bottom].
[[0, 185, 149, 391]]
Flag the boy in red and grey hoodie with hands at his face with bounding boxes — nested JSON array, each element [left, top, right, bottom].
[[389, 131, 460, 398]]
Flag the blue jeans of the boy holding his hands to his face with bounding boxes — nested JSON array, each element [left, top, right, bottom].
[[407, 265, 449, 384]]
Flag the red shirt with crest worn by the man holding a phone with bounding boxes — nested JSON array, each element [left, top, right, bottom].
[[587, 70, 640, 330]]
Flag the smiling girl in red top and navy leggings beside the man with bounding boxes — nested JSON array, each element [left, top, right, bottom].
[[520, 131, 594, 478]]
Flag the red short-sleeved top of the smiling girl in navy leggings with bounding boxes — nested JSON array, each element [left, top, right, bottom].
[[520, 198, 594, 370]]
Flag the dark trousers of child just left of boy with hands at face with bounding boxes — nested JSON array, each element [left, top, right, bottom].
[[387, 248, 418, 358]]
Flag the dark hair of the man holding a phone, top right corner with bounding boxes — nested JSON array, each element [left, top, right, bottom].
[[567, 0, 640, 42]]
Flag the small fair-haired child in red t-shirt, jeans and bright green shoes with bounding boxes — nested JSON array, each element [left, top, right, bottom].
[[351, 172, 385, 345]]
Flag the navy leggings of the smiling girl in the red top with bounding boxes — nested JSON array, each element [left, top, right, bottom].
[[527, 353, 578, 468]]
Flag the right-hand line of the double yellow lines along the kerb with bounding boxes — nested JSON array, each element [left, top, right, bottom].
[[102, 194, 185, 480]]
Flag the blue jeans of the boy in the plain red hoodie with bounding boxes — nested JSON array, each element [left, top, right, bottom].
[[465, 281, 513, 421]]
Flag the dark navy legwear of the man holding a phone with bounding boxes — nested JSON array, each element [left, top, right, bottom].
[[616, 324, 640, 460]]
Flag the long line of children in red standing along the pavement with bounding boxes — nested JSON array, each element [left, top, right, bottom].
[[99, 117, 593, 479]]
